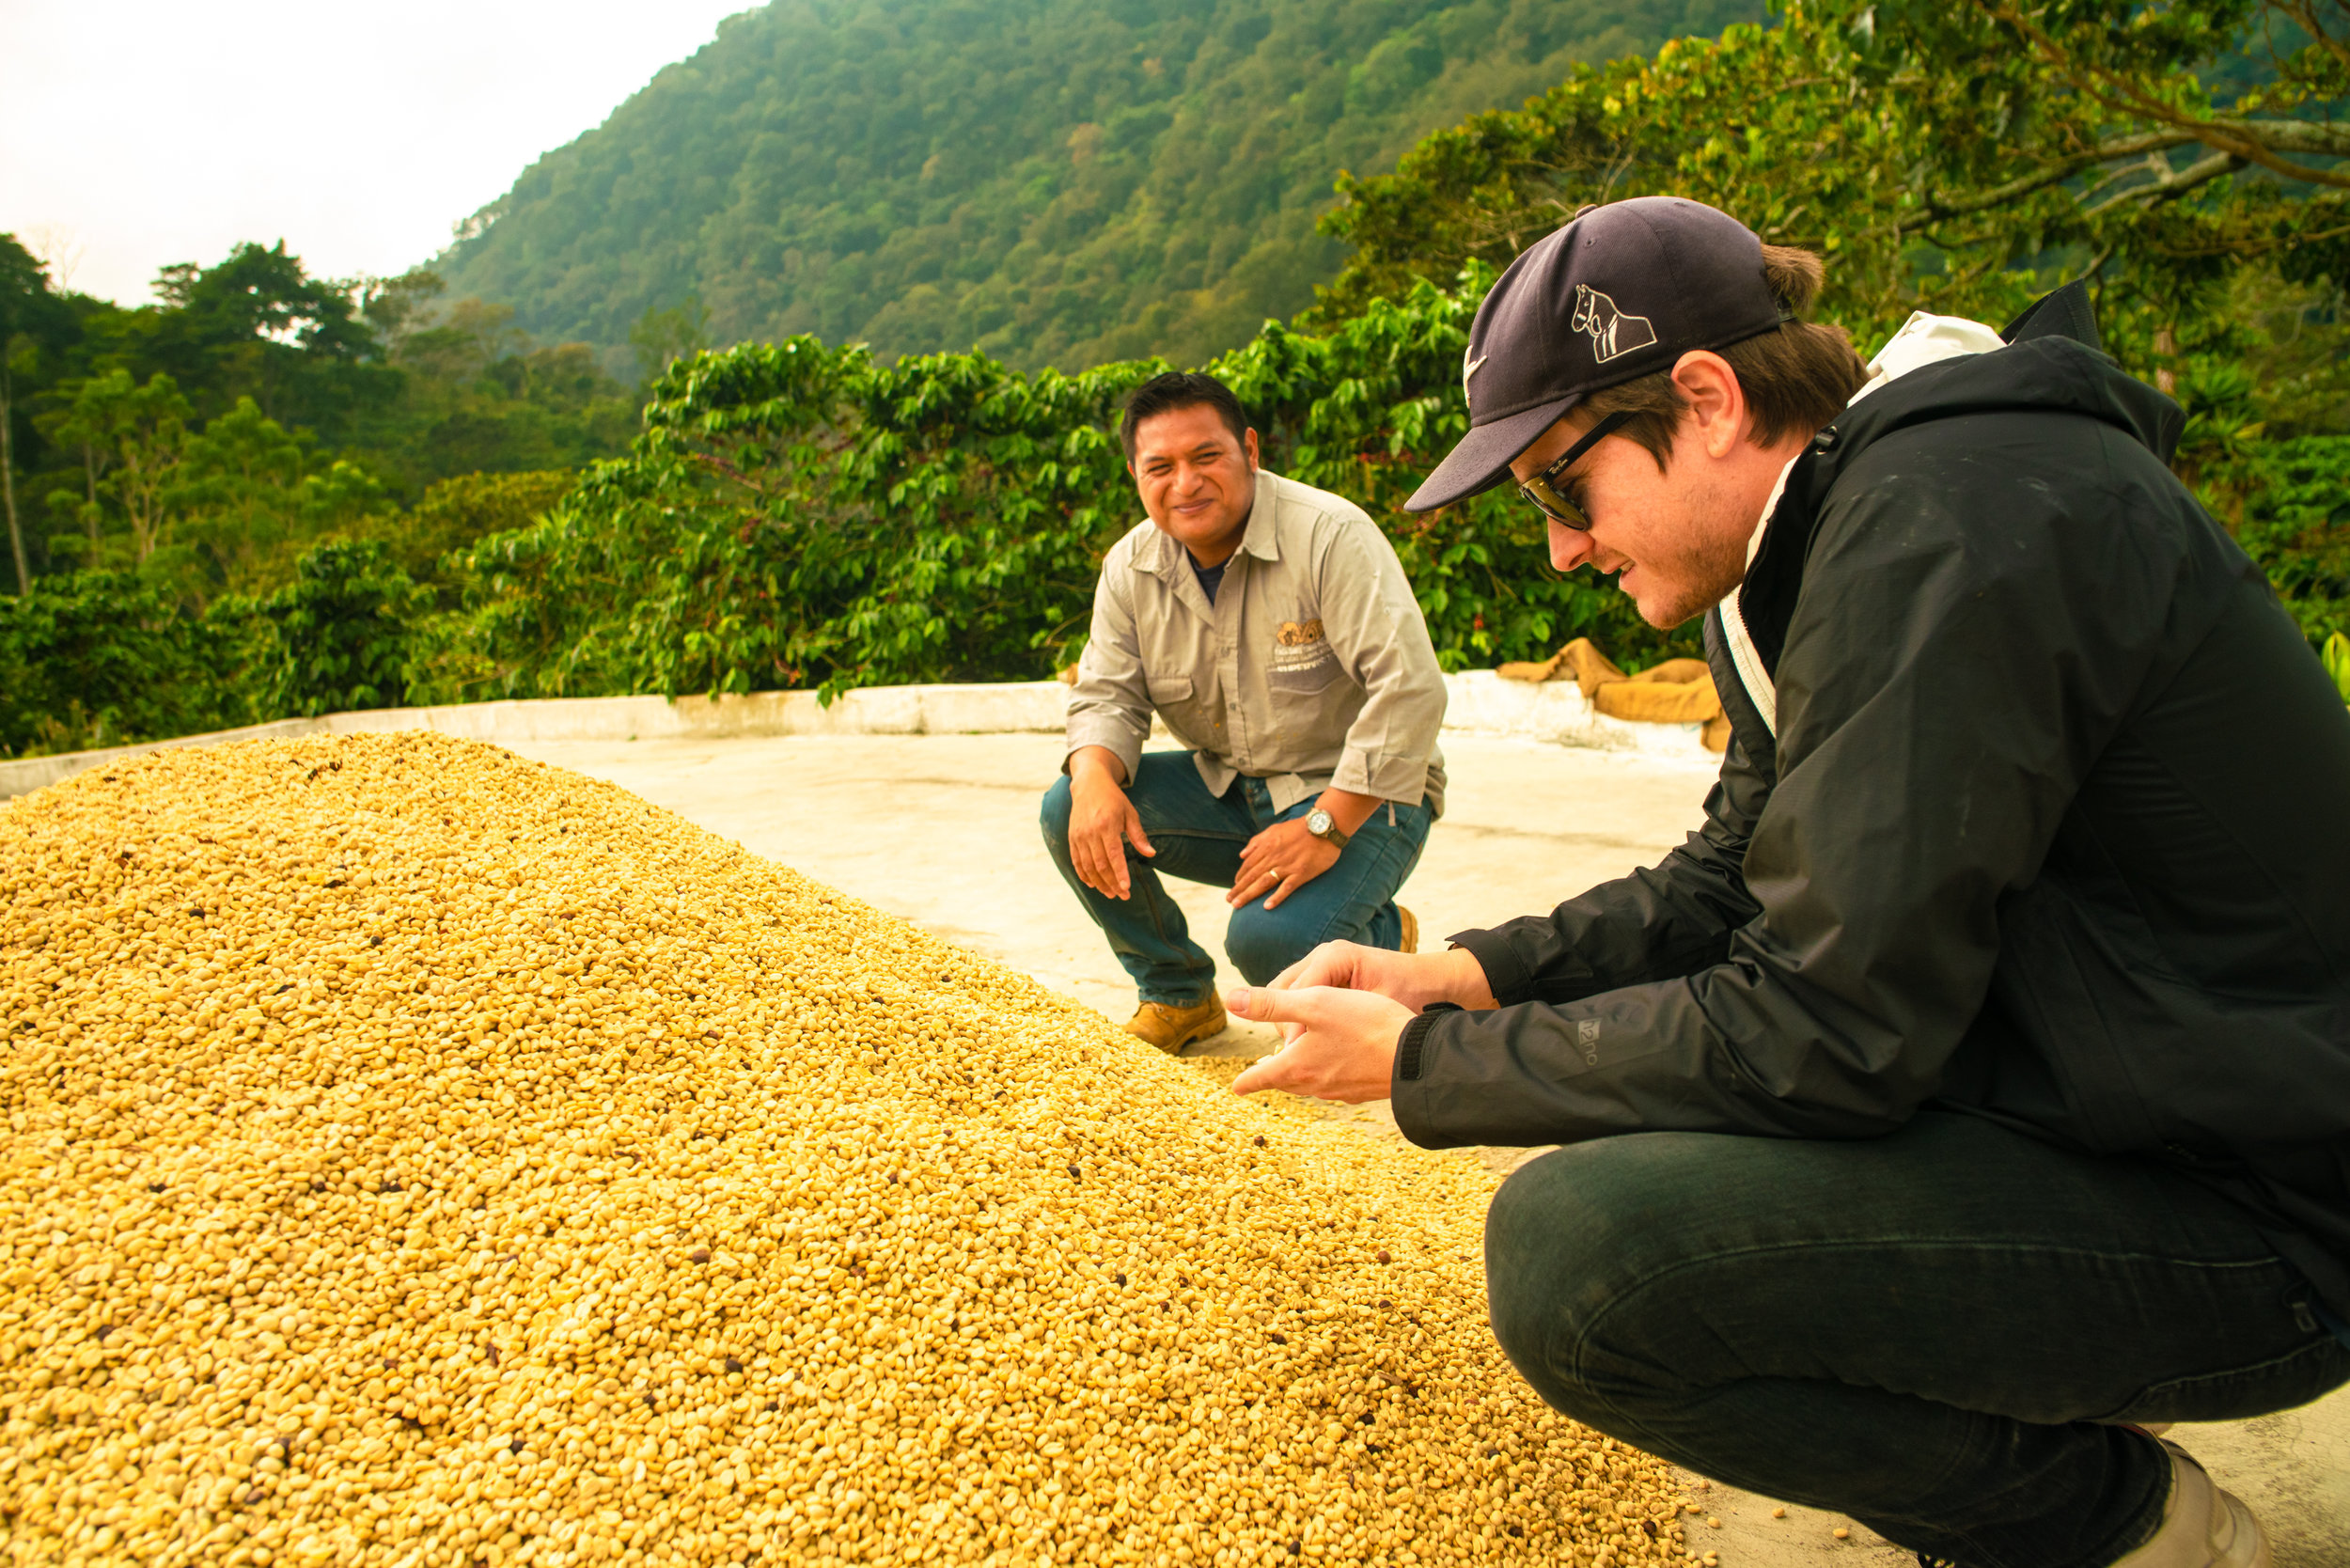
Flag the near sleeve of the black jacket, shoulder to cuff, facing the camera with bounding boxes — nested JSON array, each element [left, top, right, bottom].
[[1394, 431, 2179, 1147]]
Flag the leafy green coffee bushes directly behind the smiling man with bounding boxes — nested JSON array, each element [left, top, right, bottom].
[[404, 273, 1662, 698]]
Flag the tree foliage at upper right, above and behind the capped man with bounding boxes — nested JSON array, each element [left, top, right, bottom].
[[1305, 0, 2350, 637]]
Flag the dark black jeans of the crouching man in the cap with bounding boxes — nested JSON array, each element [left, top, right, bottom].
[[1485, 1112, 2350, 1568]]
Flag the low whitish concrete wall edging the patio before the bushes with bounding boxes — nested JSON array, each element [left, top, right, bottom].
[[0, 670, 1714, 799]]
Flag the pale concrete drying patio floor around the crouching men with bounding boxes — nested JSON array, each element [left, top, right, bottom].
[[472, 733, 2350, 1568]]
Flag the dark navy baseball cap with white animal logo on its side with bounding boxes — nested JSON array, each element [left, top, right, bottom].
[[1403, 196, 1791, 512]]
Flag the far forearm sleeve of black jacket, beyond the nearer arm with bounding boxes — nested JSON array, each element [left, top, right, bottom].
[[1452, 741, 1767, 1006]]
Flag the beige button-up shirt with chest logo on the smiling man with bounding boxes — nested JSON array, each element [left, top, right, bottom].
[[1070, 470, 1446, 813]]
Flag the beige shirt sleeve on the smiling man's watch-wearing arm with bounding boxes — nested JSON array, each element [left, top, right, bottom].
[[1316, 520, 1446, 804]]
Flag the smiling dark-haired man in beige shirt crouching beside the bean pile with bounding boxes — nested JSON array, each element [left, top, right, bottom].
[[1043, 374, 1446, 1051]]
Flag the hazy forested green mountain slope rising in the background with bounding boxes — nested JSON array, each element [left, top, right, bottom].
[[435, 0, 1762, 369]]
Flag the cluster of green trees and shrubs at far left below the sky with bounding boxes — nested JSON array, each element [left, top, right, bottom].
[[0, 235, 637, 755]]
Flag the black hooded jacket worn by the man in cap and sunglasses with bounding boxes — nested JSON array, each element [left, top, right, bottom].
[[1394, 301, 2350, 1319]]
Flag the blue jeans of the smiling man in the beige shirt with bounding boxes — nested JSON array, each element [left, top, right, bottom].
[[1043, 752, 1434, 1006]]
